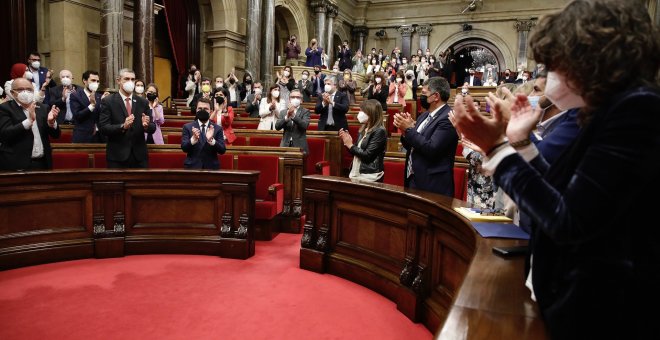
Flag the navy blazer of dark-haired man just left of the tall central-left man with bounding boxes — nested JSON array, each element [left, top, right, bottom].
[[70, 88, 103, 143]]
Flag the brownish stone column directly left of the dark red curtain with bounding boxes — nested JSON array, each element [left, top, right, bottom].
[[133, 0, 154, 84]]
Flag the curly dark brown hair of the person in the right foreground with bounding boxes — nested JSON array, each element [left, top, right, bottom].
[[530, 0, 660, 123]]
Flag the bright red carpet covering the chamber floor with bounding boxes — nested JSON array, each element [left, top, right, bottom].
[[0, 234, 432, 340]]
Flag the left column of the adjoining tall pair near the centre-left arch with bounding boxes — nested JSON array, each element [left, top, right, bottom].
[[245, 0, 261, 80]]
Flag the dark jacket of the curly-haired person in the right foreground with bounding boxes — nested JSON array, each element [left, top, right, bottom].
[[493, 88, 660, 339]]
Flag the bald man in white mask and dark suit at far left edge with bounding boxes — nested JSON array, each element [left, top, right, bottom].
[[0, 78, 60, 170]]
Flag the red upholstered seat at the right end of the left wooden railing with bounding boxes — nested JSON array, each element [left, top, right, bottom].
[[237, 155, 284, 220]]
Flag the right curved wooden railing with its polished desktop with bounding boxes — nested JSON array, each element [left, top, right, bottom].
[[300, 176, 547, 340]]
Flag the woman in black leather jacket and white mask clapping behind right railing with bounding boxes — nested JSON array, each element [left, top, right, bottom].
[[339, 99, 387, 182]]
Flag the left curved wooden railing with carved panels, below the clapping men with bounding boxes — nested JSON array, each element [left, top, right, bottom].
[[0, 169, 259, 269]]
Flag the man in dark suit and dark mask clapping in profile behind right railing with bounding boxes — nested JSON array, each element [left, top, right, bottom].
[[394, 77, 458, 197]]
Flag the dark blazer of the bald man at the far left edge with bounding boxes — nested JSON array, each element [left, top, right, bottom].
[[0, 100, 60, 170]]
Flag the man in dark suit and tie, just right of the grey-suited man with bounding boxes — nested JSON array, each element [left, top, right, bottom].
[[316, 77, 348, 131]]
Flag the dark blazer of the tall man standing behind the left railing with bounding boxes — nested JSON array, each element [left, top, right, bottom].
[[98, 93, 156, 162]]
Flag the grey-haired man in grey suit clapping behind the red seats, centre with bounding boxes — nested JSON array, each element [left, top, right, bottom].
[[275, 89, 310, 154]]
